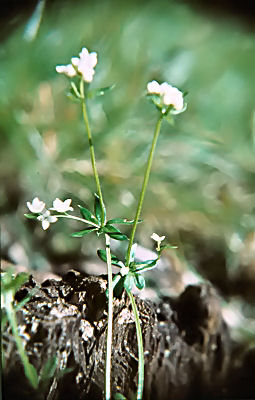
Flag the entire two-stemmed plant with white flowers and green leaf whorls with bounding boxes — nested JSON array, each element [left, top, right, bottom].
[[25, 47, 186, 400]]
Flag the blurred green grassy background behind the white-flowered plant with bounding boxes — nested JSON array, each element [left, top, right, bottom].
[[0, 0, 255, 300]]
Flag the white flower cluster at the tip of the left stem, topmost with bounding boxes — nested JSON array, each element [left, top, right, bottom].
[[56, 47, 97, 82]]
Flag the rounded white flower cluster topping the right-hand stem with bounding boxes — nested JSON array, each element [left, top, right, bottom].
[[147, 81, 185, 113]]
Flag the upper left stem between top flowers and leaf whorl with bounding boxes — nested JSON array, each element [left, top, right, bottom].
[[80, 78, 105, 225]]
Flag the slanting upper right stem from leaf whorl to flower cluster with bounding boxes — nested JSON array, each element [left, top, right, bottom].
[[127, 114, 163, 266]]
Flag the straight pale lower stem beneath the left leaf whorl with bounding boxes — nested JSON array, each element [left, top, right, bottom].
[[105, 235, 113, 400]]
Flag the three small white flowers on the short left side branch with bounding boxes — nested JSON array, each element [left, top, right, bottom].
[[27, 197, 73, 230]]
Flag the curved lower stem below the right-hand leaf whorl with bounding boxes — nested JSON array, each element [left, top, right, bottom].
[[127, 290, 144, 400]]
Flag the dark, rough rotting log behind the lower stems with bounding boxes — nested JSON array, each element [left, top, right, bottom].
[[2, 270, 233, 400]]
